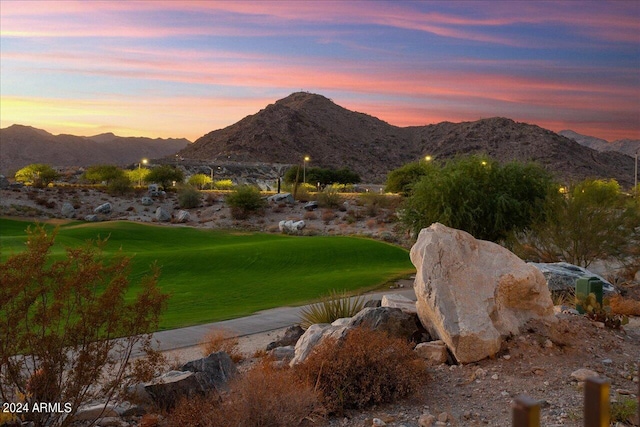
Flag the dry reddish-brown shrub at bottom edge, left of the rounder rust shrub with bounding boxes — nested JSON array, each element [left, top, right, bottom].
[[168, 360, 323, 427]]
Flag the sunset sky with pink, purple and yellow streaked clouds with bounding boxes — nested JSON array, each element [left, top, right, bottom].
[[0, 0, 640, 141]]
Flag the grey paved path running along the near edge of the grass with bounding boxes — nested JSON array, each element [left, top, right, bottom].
[[145, 279, 416, 351]]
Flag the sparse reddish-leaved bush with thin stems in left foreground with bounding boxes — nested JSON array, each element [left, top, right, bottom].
[[0, 225, 167, 426]]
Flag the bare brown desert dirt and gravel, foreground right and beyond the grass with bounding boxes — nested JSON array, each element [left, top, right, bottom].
[[0, 188, 640, 427]]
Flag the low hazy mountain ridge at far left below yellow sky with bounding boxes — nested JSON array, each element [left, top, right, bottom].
[[0, 125, 190, 174]]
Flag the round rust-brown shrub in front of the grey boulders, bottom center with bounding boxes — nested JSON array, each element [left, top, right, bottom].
[[295, 328, 427, 413]]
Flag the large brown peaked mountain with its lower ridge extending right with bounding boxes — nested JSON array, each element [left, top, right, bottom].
[[179, 92, 633, 186]]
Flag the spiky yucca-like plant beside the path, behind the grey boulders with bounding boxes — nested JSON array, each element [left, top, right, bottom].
[[300, 290, 365, 329]]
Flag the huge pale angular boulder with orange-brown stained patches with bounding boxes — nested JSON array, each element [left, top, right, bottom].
[[410, 223, 556, 363]]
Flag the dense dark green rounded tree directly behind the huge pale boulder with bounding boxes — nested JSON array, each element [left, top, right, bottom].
[[401, 156, 554, 242]]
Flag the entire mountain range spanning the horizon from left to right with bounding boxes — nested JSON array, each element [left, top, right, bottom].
[[0, 92, 634, 187]]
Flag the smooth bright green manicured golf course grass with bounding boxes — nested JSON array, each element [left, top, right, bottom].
[[0, 218, 415, 329]]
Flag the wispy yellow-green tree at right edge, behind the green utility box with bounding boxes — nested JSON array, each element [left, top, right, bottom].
[[513, 180, 640, 267]]
